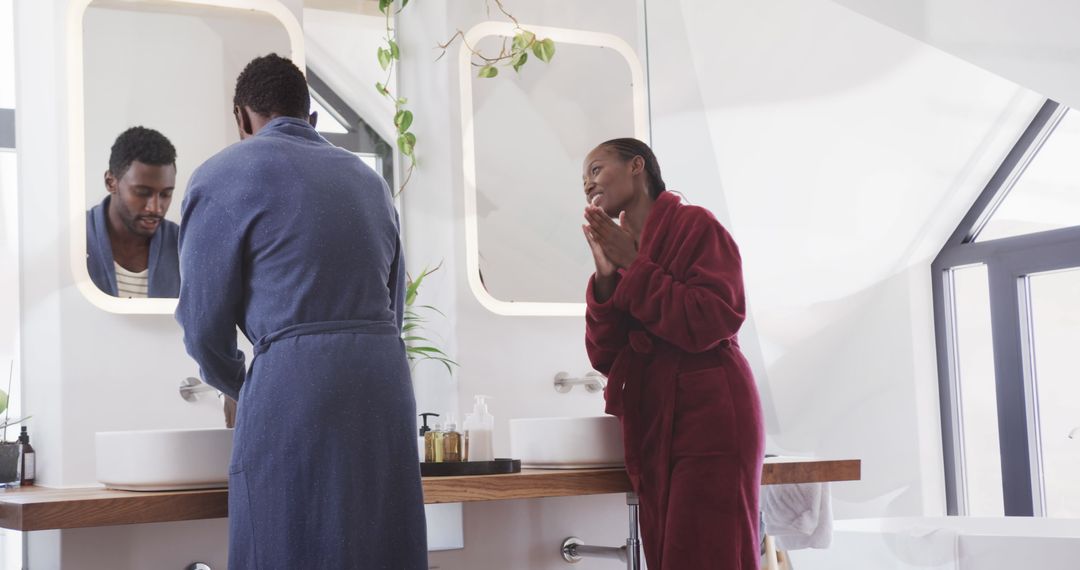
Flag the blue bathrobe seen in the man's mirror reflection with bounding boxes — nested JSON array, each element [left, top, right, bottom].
[[86, 194, 180, 299]]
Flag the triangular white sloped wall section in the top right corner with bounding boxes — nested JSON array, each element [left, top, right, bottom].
[[833, 0, 1080, 108]]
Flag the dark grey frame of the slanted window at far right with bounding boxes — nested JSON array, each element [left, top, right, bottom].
[[931, 99, 1080, 516]]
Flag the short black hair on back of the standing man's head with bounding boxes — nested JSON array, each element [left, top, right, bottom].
[[232, 54, 311, 119]]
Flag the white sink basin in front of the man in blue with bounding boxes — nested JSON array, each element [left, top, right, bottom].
[[95, 428, 232, 491]]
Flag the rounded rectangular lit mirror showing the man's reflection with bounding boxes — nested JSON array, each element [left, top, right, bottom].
[[68, 0, 305, 313]]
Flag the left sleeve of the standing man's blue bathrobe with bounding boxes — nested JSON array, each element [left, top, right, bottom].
[[176, 180, 245, 399]]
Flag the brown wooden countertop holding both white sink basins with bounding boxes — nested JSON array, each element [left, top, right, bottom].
[[0, 459, 861, 531]]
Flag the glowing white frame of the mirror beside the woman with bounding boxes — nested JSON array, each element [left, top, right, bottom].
[[458, 22, 649, 316]]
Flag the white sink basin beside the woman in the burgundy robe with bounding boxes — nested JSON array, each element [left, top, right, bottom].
[[510, 416, 623, 469]]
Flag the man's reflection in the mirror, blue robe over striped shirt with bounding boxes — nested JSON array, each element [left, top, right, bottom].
[[86, 126, 180, 299]]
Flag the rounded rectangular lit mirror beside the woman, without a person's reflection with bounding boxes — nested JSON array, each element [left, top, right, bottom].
[[459, 22, 649, 315]]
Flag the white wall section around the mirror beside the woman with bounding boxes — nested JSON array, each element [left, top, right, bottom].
[[400, 0, 638, 570]]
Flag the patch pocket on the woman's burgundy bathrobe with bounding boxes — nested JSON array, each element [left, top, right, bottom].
[[672, 368, 737, 457]]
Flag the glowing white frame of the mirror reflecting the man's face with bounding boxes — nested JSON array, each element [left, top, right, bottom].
[[67, 0, 307, 314]]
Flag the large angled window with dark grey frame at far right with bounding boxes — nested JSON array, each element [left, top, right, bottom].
[[932, 100, 1080, 517]]
